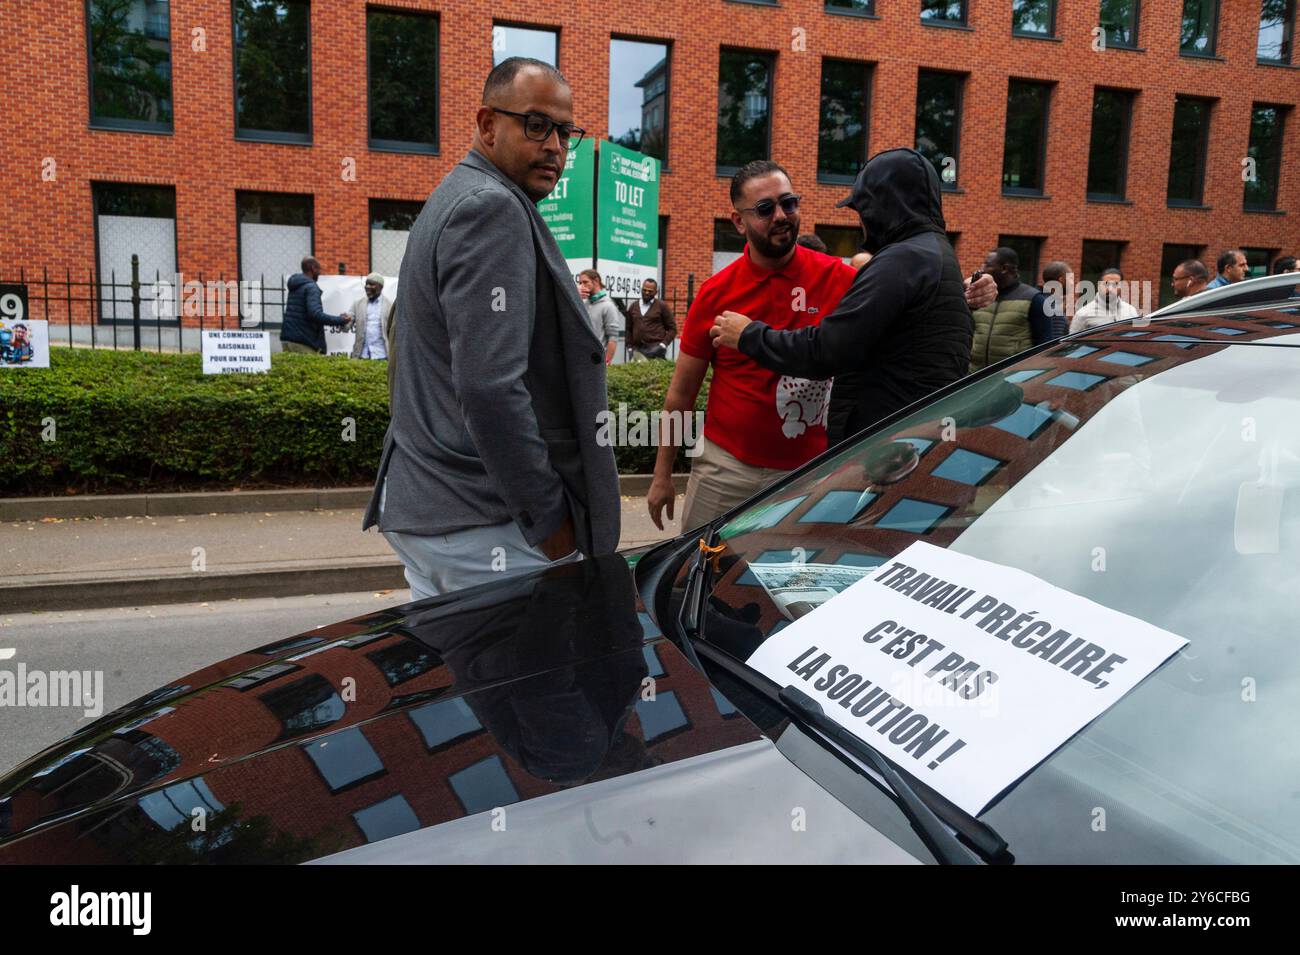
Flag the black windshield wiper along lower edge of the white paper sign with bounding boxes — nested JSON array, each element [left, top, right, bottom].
[[684, 639, 1014, 865]]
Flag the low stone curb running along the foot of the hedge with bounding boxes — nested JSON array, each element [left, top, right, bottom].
[[0, 474, 686, 522]]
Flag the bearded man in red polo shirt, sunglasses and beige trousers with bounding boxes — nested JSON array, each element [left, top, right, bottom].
[[646, 160, 857, 529]]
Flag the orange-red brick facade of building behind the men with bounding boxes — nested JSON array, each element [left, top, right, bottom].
[[0, 0, 1300, 298]]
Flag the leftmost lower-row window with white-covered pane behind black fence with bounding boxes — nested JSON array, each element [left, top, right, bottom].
[[91, 182, 176, 320]]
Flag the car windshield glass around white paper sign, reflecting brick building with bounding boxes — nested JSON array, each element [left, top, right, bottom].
[[706, 320, 1300, 863]]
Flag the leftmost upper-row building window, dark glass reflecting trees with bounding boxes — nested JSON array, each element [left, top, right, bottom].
[[86, 0, 172, 133]]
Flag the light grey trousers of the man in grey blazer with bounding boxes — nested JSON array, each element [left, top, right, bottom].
[[380, 478, 582, 600]]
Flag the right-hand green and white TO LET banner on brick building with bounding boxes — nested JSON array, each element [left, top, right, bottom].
[[595, 140, 659, 299]]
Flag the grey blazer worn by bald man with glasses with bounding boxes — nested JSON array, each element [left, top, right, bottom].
[[363, 149, 620, 560]]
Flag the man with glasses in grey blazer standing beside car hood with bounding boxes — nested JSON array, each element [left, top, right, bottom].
[[363, 57, 619, 599]]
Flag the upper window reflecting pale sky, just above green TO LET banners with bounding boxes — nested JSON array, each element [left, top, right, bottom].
[[608, 40, 670, 161]]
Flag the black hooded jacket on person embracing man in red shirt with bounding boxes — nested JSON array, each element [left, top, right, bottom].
[[738, 149, 974, 444]]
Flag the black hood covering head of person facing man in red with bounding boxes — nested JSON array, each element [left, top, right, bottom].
[[836, 149, 946, 255]]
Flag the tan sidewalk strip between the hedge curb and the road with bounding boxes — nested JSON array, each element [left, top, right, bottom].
[[0, 495, 681, 613]]
